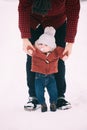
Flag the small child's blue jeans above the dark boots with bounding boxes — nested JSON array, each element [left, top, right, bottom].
[[35, 73, 58, 104]]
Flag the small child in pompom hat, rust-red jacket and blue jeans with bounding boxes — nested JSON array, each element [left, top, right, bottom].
[[27, 27, 64, 112]]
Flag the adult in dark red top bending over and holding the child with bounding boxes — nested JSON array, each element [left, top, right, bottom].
[[18, 0, 80, 109]]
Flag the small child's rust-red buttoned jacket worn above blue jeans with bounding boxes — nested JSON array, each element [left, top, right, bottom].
[[31, 47, 64, 74]]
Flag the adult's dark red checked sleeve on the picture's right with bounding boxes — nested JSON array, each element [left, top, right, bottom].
[[65, 0, 80, 43]]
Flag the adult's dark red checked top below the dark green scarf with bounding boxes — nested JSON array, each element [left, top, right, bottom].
[[18, 0, 80, 42]]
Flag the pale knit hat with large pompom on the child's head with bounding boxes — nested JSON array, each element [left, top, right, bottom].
[[35, 26, 56, 50]]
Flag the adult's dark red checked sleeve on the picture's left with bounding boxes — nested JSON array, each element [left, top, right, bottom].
[[18, 0, 31, 38]]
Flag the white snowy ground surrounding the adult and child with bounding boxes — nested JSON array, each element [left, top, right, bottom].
[[0, 0, 87, 130]]
